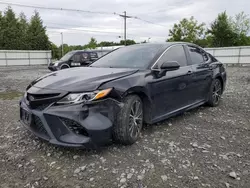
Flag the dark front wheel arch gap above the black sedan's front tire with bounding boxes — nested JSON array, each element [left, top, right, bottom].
[[122, 86, 152, 123]]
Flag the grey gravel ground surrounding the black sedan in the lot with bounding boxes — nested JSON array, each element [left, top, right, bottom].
[[0, 67, 250, 188]]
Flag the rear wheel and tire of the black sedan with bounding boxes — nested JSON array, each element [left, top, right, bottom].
[[207, 78, 222, 107]]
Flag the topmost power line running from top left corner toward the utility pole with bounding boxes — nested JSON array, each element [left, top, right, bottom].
[[0, 1, 113, 15]]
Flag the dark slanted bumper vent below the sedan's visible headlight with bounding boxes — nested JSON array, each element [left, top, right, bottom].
[[60, 117, 89, 136]]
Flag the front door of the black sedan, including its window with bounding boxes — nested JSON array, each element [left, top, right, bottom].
[[147, 44, 193, 118]]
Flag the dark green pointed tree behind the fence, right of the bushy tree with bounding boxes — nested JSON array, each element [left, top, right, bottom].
[[209, 12, 237, 47]]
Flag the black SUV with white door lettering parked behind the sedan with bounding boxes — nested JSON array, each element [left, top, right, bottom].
[[48, 50, 109, 71]]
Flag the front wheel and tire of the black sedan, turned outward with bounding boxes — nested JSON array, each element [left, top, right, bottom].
[[113, 95, 143, 145]]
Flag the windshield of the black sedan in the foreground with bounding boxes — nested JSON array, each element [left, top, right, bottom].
[[91, 44, 162, 68]]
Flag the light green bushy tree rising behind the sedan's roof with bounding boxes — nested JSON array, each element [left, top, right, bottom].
[[168, 16, 205, 43]]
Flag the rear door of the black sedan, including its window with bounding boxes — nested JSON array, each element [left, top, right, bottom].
[[185, 45, 213, 102]]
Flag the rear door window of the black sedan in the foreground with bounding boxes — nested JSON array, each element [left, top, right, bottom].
[[188, 46, 208, 65]]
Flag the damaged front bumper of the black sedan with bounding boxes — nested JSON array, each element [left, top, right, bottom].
[[20, 98, 121, 147]]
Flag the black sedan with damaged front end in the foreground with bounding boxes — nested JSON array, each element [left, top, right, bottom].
[[20, 42, 226, 147]]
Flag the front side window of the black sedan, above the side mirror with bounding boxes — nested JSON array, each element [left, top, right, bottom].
[[154, 45, 187, 68]]
